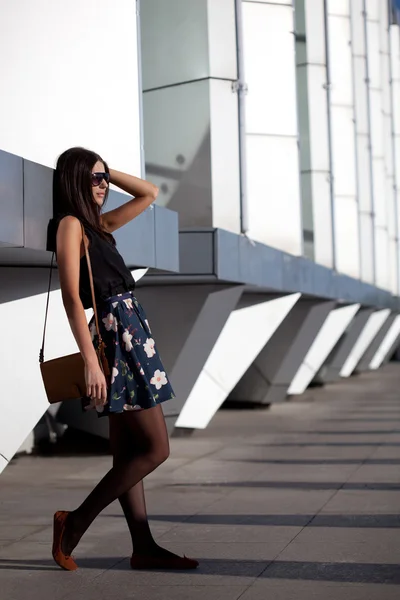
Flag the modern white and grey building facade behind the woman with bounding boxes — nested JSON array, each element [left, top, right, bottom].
[[0, 0, 400, 471]]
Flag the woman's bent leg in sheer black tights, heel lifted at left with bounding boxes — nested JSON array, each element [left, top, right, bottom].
[[62, 405, 169, 555]]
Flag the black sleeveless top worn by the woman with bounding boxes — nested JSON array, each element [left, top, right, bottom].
[[47, 214, 135, 308]]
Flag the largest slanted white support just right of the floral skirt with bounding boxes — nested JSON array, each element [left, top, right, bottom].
[[176, 294, 300, 428]]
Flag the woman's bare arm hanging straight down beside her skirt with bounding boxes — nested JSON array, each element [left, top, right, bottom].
[[57, 216, 106, 401]]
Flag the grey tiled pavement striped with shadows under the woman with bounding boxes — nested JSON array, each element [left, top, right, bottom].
[[0, 364, 400, 600]]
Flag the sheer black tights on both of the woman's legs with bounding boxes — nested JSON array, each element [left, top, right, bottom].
[[63, 405, 172, 556]]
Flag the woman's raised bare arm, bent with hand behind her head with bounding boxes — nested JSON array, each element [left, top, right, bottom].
[[101, 169, 158, 233]]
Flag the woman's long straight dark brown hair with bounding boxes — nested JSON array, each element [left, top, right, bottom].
[[53, 147, 115, 244]]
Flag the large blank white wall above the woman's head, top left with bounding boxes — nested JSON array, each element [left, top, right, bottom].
[[0, 0, 140, 174]]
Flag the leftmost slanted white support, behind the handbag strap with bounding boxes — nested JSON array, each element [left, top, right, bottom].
[[0, 268, 89, 474]]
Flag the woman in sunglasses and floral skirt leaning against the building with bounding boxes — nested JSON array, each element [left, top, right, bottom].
[[49, 148, 198, 571]]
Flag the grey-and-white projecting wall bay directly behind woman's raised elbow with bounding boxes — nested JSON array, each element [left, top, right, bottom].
[[141, 0, 241, 233]]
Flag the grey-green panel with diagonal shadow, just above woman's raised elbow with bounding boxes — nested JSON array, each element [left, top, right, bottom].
[[143, 81, 212, 227]]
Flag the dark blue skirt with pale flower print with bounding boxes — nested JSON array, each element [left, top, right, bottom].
[[83, 292, 175, 416]]
